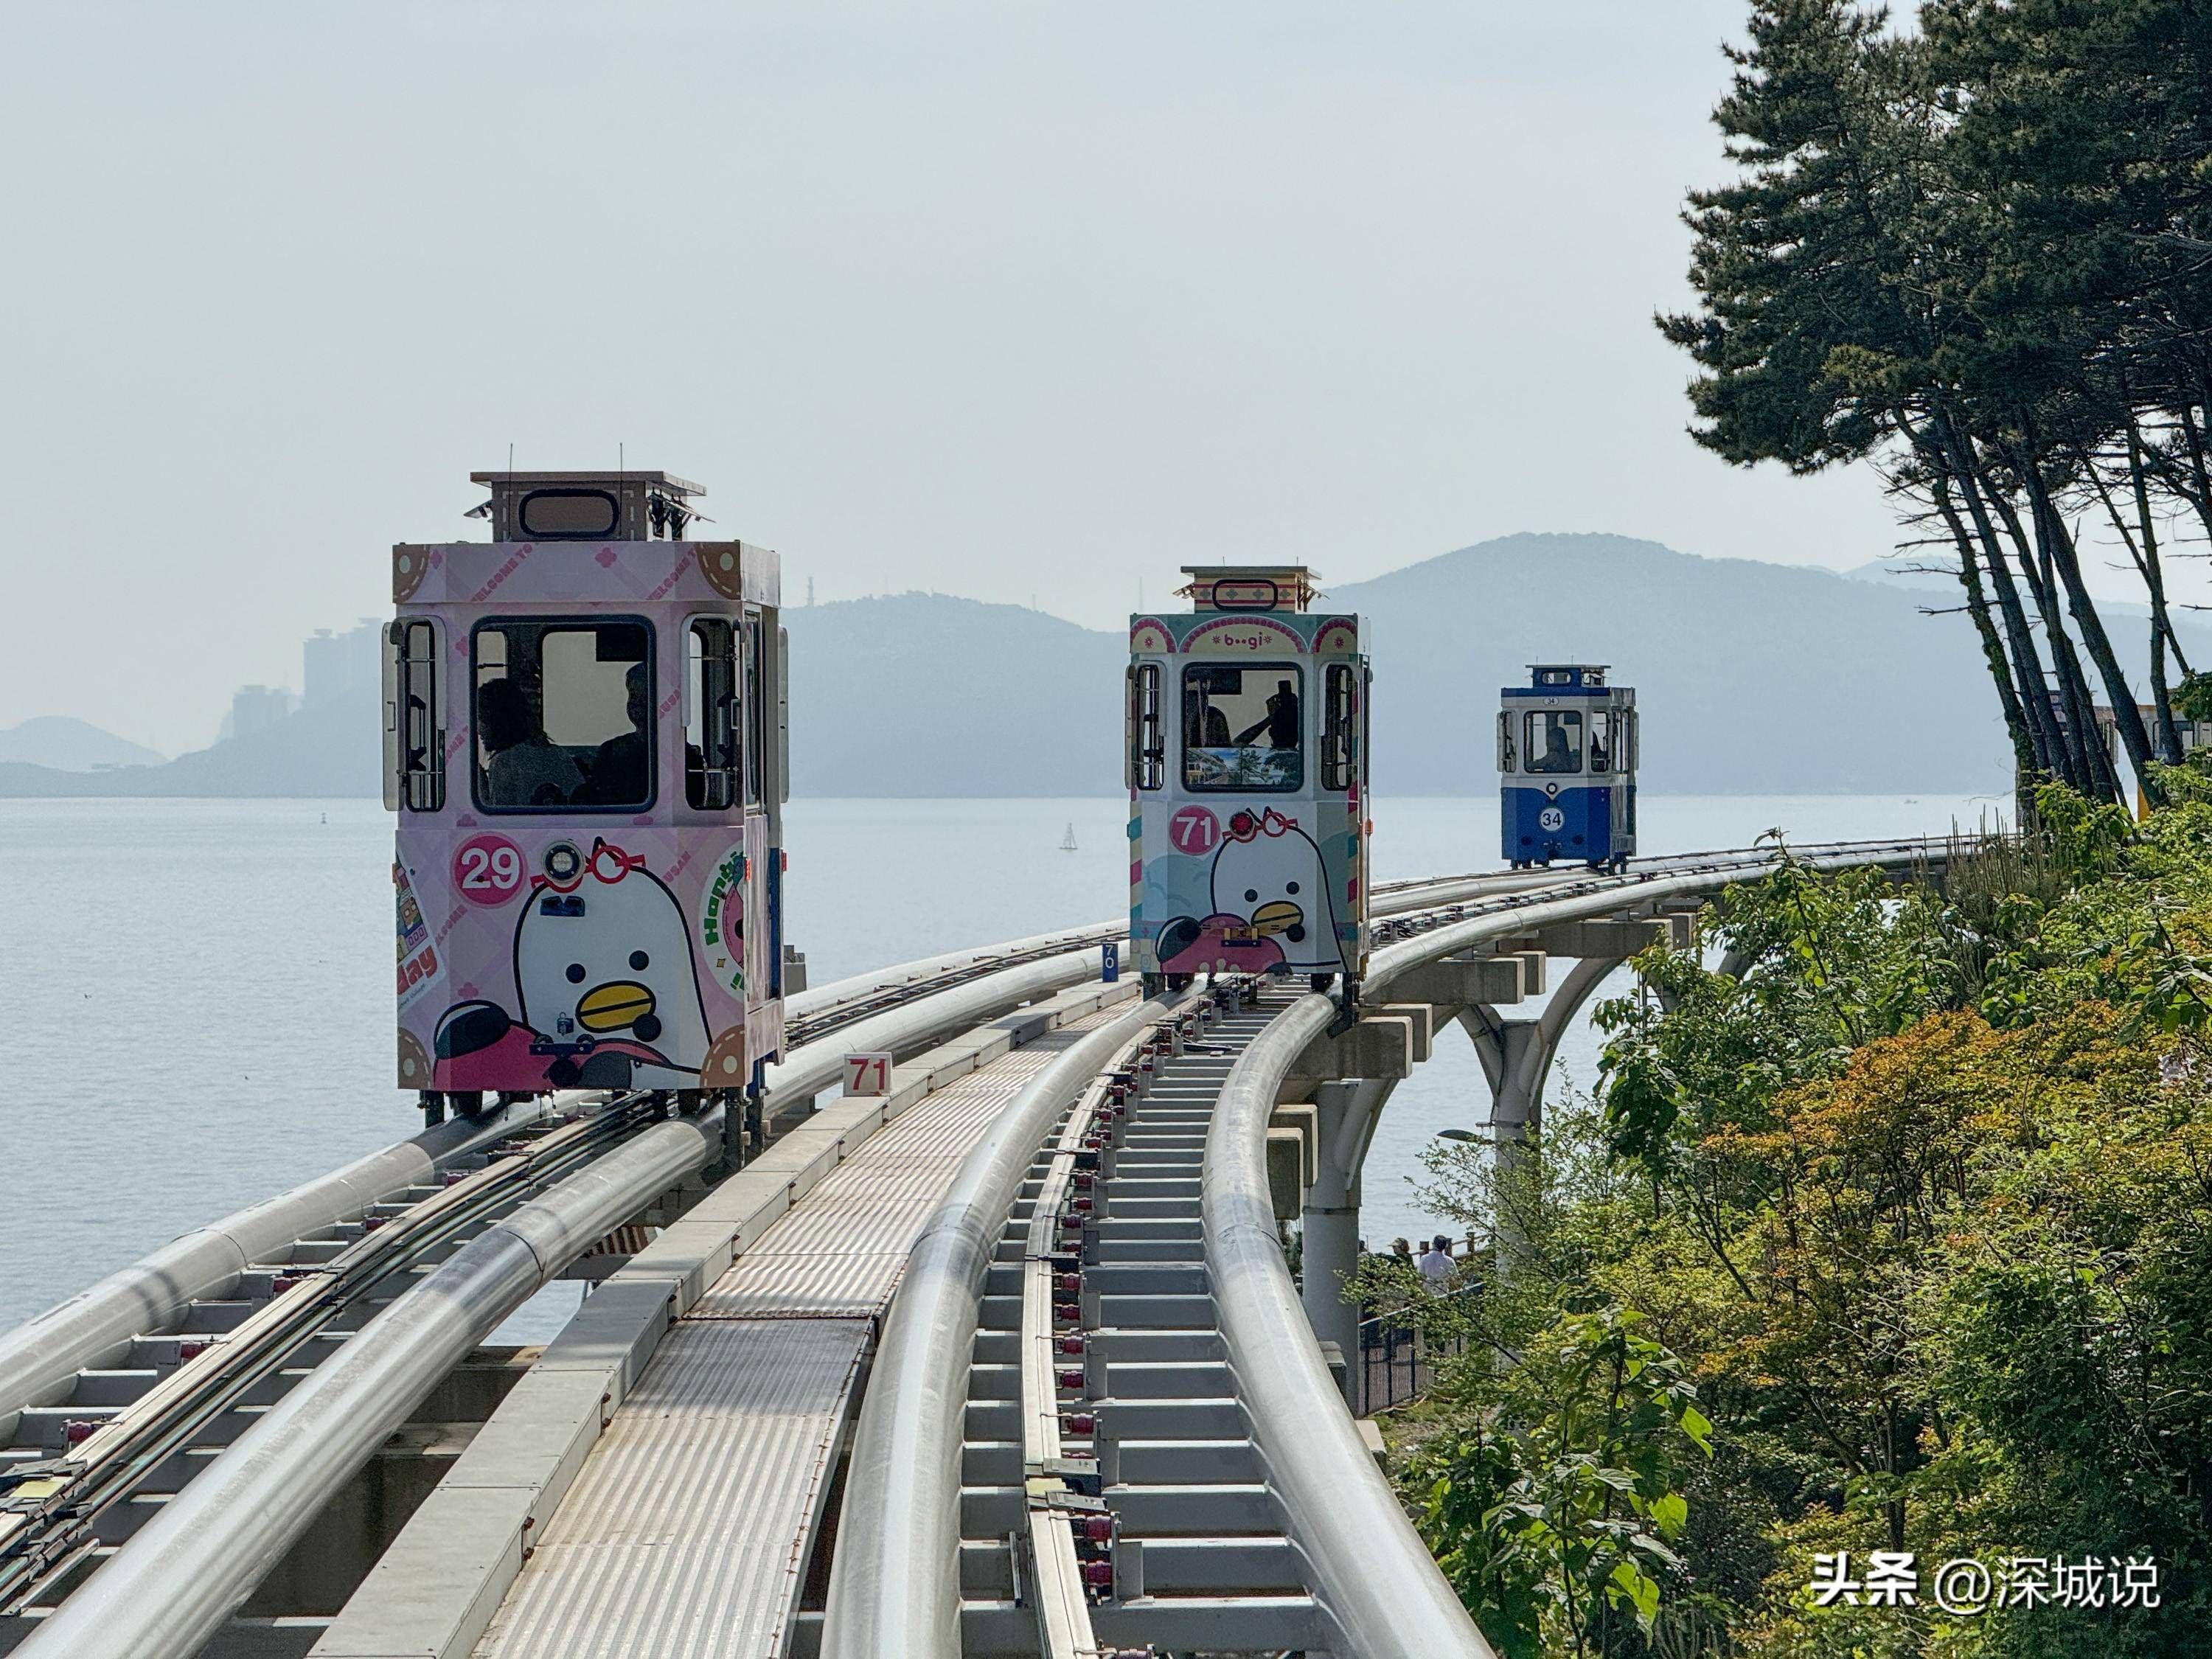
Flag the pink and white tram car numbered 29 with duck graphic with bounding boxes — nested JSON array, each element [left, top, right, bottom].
[[385, 471, 801, 1121]]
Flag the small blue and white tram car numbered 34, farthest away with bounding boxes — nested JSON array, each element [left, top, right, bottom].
[[1498, 664, 1637, 869]]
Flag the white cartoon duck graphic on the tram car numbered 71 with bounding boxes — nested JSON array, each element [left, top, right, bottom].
[[1159, 807, 1343, 973]]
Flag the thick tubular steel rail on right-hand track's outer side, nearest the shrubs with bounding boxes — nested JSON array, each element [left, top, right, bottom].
[[1201, 841, 1931, 1659]]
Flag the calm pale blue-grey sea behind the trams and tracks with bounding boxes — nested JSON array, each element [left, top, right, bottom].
[[0, 794, 2002, 1329]]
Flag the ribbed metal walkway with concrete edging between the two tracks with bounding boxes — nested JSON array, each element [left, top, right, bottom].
[[314, 987, 1135, 1659]]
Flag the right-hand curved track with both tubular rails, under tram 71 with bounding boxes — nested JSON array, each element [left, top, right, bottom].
[[823, 841, 1942, 1659]]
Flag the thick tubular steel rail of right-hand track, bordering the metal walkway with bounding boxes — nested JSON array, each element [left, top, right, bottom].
[[821, 998, 1183, 1659]]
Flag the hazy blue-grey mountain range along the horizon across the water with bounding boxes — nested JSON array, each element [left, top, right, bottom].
[[13, 535, 2212, 796]]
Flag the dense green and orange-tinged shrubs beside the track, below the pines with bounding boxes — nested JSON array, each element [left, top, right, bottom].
[[1349, 770, 2212, 1659]]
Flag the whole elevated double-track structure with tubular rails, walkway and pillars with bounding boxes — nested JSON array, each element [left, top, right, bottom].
[[0, 841, 1947, 1659]]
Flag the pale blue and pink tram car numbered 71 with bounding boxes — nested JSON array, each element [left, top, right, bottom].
[[1126, 566, 1369, 1000]]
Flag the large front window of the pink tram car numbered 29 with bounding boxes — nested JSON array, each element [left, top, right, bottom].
[[471, 617, 655, 812]]
